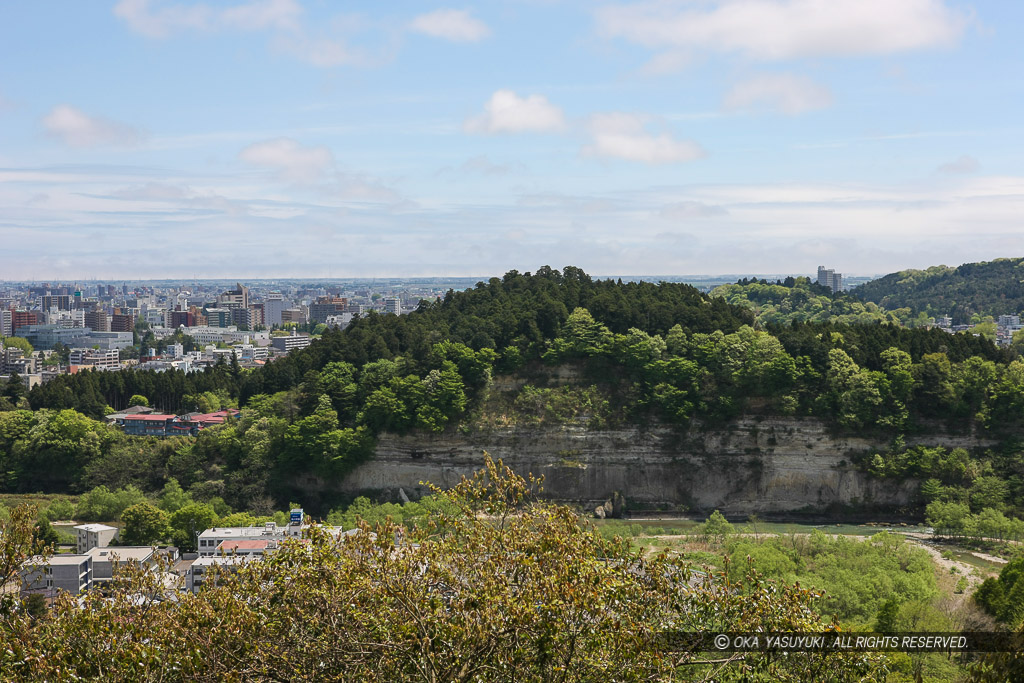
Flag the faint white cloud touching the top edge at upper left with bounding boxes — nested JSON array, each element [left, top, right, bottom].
[[114, 0, 302, 38]]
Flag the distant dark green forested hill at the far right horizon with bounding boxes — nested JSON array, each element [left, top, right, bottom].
[[852, 258, 1024, 325]]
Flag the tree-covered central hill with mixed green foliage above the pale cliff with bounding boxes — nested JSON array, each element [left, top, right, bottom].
[[6, 267, 1024, 516]]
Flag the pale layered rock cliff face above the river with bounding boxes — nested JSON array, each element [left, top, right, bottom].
[[331, 418, 986, 516]]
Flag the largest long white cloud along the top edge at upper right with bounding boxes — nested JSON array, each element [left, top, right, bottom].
[[596, 0, 970, 60]]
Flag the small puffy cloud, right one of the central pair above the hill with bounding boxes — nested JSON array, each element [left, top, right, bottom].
[[583, 113, 707, 164]]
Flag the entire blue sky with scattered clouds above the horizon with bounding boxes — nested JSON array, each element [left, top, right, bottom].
[[0, 0, 1024, 281]]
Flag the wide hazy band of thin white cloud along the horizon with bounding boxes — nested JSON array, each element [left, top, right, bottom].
[[6, 160, 1024, 280]]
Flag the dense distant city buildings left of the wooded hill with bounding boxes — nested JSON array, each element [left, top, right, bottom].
[[0, 282, 432, 389]]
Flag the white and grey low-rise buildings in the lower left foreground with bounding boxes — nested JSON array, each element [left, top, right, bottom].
[[20, 509, 359, 598]]
